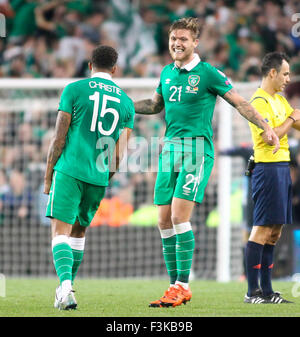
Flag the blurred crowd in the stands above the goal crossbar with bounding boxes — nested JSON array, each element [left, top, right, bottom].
[[0, 0, 300, 81]]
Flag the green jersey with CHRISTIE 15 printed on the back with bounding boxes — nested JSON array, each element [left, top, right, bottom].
[[54, 72, 135, 186]]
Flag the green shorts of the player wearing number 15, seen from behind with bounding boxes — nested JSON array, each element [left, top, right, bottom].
[[46, 171, 105, 227]]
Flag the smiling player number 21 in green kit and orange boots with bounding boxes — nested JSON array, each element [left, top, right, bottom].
[[135, 18, 279, 307]]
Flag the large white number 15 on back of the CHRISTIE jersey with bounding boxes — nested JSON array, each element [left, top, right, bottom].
[[89, 91, 120, 136]]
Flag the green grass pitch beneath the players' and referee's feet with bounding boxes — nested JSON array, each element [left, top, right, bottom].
[[0, 278, 300, 317]]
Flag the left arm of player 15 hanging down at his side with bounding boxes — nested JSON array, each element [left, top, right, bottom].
[[44, 111, 72, 194]]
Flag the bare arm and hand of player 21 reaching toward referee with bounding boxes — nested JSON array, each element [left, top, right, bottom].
[[223, 89, 280, 153]]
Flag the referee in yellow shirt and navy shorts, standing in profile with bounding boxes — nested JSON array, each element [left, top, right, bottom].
[[244, 52, 300, 304]]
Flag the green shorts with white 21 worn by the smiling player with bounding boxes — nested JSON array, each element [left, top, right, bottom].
[[154, 151, 214, 205]]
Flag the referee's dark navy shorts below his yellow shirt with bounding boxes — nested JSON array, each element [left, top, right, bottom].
[[252, 162, 292, 226]]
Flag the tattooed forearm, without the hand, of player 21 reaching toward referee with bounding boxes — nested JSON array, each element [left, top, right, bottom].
[[223, 89, 267, 130]]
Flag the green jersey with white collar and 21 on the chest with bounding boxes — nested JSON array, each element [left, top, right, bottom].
[[156, 54, 232, 157]]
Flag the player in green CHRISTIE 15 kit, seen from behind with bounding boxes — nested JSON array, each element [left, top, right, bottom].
[[44, 46, 135, 310]]
